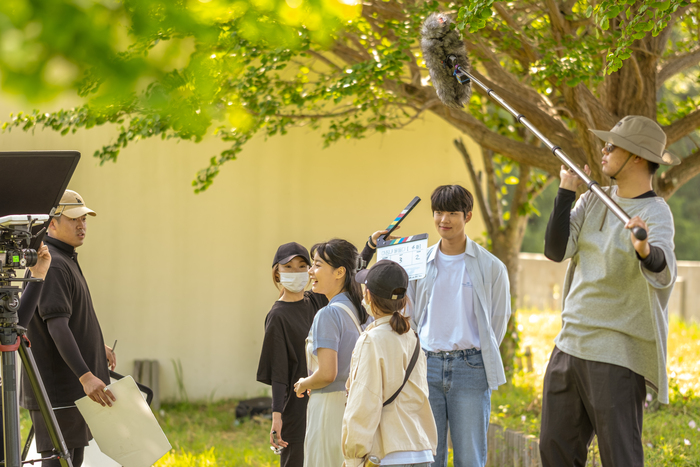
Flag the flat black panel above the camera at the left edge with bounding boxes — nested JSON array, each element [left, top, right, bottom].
[[0, 151, 80, 217]]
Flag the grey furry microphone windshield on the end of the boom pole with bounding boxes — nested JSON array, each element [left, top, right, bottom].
[[420, 13, 472, 109]]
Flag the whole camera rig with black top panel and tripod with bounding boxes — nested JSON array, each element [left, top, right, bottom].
[[0, 151, 80, 467]]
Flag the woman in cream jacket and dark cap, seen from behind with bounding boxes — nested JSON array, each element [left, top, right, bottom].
[[342, 260, 437, 467]]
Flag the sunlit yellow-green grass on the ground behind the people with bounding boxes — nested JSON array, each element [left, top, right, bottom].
[[139, 310, 700, 467]]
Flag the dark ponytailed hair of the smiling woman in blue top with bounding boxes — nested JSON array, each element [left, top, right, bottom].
[[311, 238, 369, 324]]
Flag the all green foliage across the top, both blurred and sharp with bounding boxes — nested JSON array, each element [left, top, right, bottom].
[[0, 0, 697, 196]]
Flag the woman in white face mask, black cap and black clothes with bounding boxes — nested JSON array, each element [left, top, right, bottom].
[[257, 242, 328, 467]]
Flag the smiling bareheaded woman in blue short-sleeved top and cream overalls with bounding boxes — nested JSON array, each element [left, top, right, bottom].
[[294, 239, 372, 467]]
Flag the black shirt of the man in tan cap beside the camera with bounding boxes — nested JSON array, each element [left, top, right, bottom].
[[21, 237, 109, 410]]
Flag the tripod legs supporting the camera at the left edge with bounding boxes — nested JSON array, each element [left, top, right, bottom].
[[0, 279, 73, 467]]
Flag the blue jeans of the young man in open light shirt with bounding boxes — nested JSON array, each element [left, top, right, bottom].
[[425, 349, 491, 467]]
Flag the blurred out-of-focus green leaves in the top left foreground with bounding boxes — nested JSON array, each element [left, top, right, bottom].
[[0, 0, 360, 101]]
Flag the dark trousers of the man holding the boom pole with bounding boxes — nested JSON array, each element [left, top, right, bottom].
[[540, 347, 646, 467]]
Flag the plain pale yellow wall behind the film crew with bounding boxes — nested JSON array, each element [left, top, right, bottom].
[[0, 100, 484, 399]]
